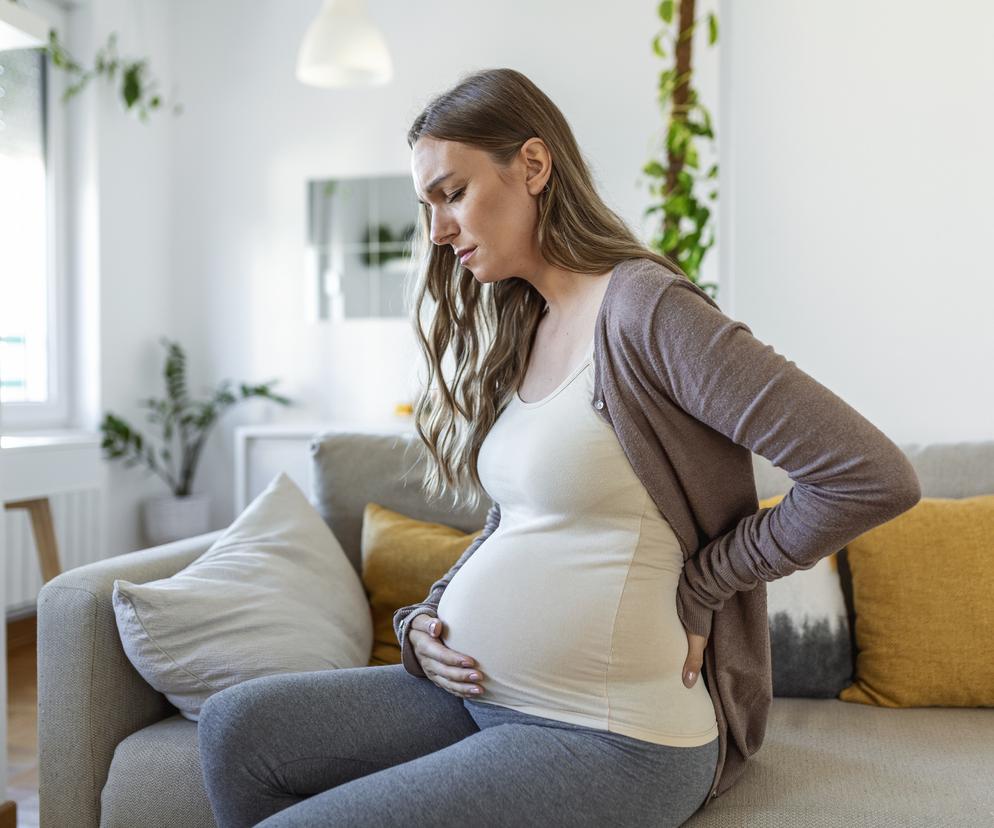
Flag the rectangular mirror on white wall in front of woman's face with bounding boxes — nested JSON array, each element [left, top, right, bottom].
[[307, 175, 418, 321]]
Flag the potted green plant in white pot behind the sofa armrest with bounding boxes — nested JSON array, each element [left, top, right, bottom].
[[100, 337, 293, 546]]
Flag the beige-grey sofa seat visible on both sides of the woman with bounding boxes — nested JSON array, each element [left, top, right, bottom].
[[100, 698, 994, 828]]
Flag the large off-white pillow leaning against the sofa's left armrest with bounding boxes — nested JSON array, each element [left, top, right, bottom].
[[113, 472, 373, 721]]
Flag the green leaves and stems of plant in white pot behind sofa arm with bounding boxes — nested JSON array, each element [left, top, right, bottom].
[[100, 338, 293, 497]]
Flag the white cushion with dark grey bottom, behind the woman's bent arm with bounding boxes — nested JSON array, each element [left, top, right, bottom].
[[759, 495, 853, 699]]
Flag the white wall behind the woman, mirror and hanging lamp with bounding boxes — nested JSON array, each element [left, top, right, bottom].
[[52, 0, 994, 554]]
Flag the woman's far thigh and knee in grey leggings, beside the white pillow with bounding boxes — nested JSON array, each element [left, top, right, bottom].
[[197, 664, 479, 828]]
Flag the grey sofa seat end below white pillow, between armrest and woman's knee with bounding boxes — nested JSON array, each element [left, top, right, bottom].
[[100, 713, 217, 828]]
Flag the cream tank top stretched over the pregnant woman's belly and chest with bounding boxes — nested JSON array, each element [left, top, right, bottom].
[[438, 339, 718, 747]]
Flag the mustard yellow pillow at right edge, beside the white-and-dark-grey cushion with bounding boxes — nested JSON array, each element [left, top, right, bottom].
[[839, 495, 994, 707]]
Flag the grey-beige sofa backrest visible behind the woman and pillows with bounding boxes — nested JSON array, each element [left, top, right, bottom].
[[310, 430, 994, 573]]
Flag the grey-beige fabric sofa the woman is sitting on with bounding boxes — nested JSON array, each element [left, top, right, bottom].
[[38, 431, 994, 828]]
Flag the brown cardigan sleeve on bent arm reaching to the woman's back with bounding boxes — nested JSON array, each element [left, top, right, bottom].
[[645, 278, 921, 636]]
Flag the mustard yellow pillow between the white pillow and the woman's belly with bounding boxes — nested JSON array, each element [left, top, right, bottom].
[[360, 503, 483, 667]]
